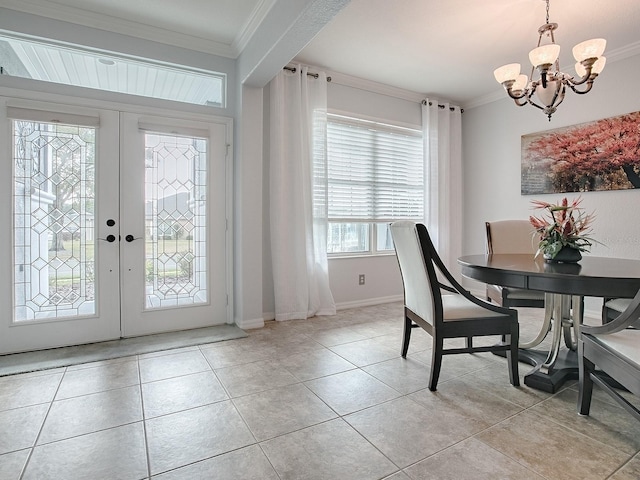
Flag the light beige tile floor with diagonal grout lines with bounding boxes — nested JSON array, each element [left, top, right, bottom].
[[0, 303, 640, 480]]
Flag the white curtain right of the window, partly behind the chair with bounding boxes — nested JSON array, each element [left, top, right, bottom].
[[422, 99, 462, 278]]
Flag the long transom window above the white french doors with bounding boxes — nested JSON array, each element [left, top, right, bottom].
[[0, 35, 227, 108]]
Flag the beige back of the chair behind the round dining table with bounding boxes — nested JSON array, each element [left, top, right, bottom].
[[485, 220, 538, 254]]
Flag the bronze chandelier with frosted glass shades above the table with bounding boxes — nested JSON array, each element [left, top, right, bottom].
[[493, 0, 607, 121]]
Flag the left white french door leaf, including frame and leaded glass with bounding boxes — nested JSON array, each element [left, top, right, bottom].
[[0, 97, 120, 354]]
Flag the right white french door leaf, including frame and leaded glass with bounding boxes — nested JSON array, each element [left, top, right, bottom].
[[120, 113, 229, 336]]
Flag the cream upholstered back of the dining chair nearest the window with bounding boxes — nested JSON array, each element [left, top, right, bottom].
[[391, 220, 442, 325]]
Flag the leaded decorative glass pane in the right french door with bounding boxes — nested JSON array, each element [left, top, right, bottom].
[[145, 133, 208, 309]]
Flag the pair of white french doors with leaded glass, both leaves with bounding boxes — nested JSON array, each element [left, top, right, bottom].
[[0, 99, 229, 353]]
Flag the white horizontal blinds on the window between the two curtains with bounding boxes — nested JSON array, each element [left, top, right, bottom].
[[327, 115, 424, 223]]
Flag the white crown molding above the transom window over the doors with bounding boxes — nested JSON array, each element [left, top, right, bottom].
[[2, 0, 238, 58]]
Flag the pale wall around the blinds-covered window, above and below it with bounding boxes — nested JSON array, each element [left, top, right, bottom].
[[262, 82, 421, 320]]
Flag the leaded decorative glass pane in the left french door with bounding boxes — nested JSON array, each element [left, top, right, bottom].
[[12, 120, 96, 322]]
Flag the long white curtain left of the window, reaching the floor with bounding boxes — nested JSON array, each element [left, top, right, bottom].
[[270, 65, 336, 320]]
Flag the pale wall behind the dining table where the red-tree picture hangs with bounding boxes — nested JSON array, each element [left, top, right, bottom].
[[462, 56, 640, 315]]
